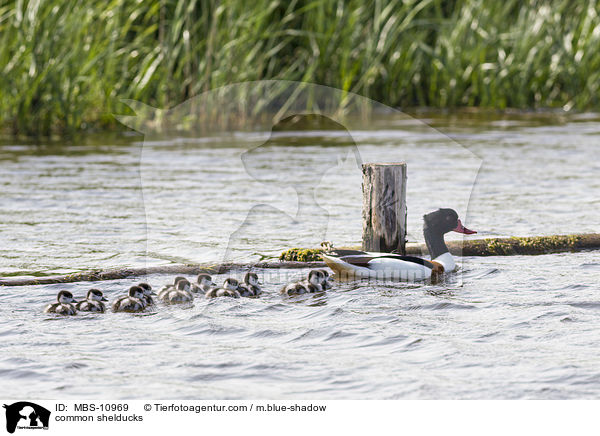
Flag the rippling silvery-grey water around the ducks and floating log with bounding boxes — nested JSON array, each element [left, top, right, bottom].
[[0, 114, 600, 399]]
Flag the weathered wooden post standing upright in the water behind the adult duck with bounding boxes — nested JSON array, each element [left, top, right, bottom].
[[362, 162, 406, 254]]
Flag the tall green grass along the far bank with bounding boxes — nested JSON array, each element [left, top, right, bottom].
[[0, 0, 600, 135]]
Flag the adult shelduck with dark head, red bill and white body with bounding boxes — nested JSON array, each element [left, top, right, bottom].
[[323, 209, 477, 282]]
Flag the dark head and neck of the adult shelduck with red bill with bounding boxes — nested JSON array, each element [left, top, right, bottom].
[[423, 209, 477, 259]]
